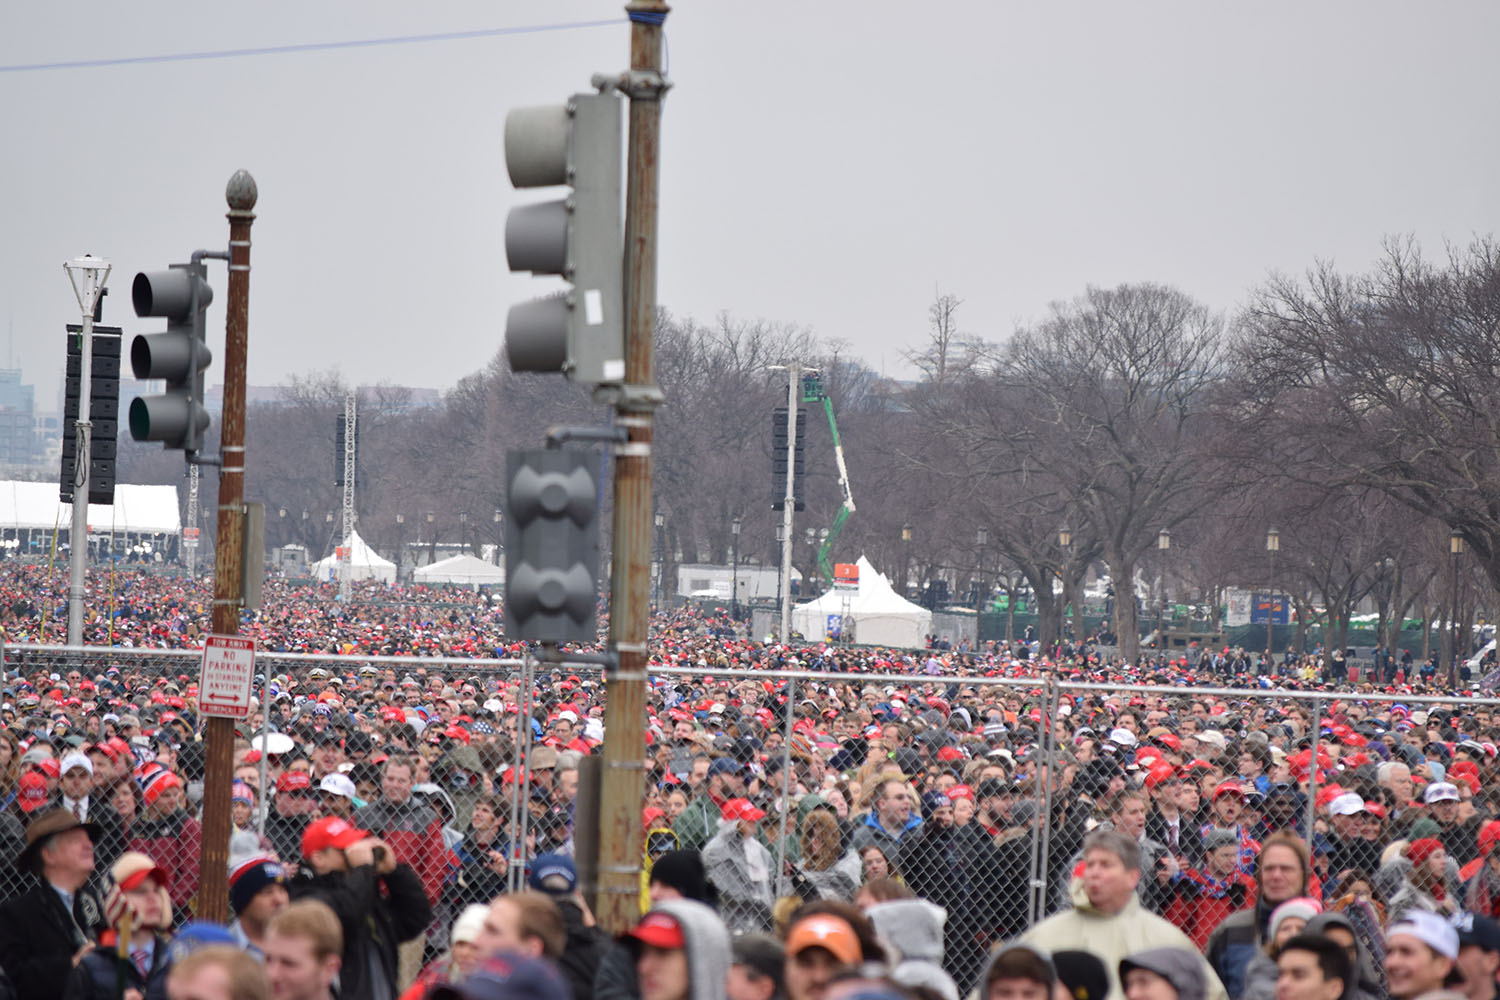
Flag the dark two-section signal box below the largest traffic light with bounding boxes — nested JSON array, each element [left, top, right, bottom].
[[506, 450, 599, 643]]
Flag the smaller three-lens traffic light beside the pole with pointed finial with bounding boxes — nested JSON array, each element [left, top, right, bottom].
[[129, 262, 213, 456]]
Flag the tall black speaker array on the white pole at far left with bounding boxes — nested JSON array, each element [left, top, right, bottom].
[[57, 322, 120, 504]]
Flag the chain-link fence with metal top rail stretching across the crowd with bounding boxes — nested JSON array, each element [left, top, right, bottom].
[[0, 646, 1500, 988]]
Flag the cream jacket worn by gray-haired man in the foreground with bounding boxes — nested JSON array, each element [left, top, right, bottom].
[[1026, 883, 1229, 1000]]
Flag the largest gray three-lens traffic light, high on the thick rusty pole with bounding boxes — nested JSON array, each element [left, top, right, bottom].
[[506, 94, 626, 382]]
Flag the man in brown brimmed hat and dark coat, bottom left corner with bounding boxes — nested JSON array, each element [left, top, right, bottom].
[[0, 808, 105, 997]]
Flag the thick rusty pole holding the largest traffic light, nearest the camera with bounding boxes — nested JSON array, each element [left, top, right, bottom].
[[597, 0, 669, 933]]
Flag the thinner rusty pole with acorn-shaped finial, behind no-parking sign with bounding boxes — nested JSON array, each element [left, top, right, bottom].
[[197, 169, 264, 924]]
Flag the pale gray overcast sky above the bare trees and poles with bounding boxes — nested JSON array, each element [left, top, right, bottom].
[[0, 0, 1500, 408]]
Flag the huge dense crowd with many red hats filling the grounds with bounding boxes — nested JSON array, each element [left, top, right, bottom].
[[0, 568, 1500, 1000]]
